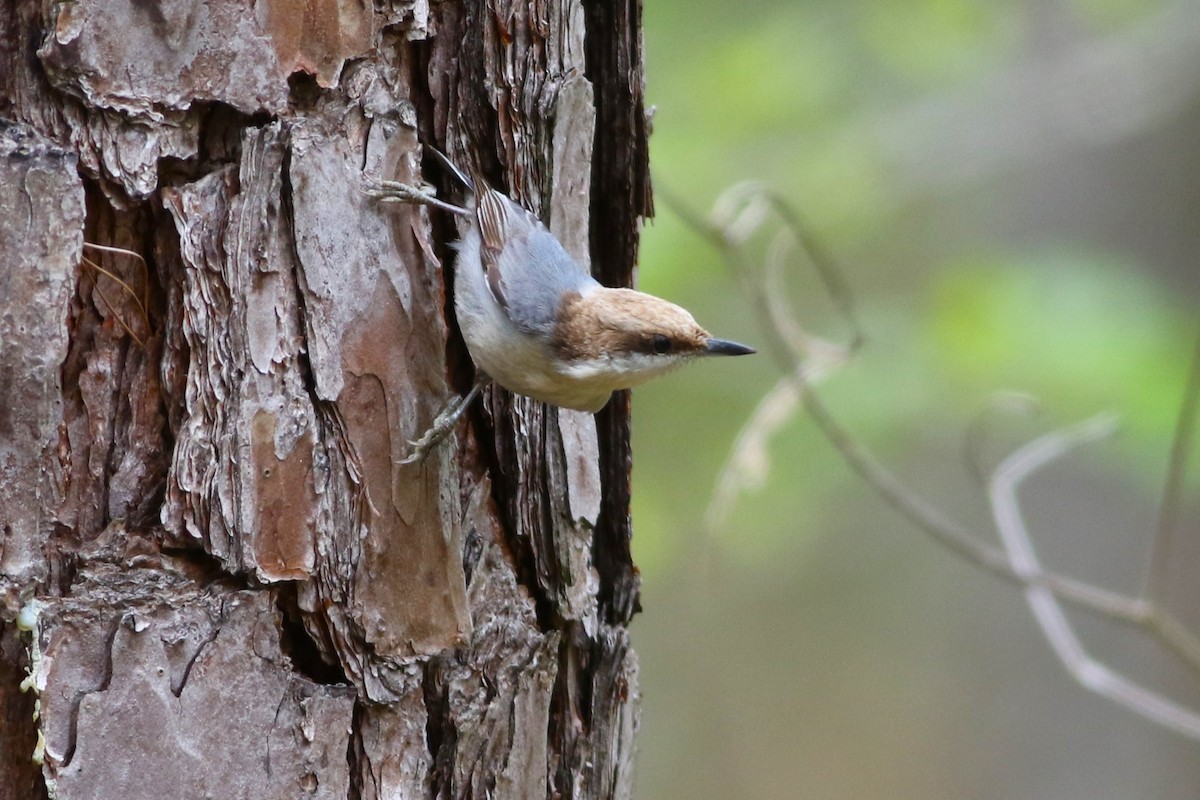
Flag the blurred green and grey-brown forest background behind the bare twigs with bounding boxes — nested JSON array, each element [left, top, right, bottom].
[[634, 0, 1200, 800]]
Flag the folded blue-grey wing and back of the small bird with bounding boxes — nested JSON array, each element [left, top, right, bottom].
[[478, 188, 599, 333]]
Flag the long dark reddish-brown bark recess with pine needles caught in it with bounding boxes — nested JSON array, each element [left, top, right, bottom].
[[56, 179, 173, 544]]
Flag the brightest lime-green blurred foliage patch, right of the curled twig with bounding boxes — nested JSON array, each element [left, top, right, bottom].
[[924, 251, 1195, 472]]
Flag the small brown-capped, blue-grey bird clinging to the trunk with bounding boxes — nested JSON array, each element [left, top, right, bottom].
[[366, 145, 755, 464]]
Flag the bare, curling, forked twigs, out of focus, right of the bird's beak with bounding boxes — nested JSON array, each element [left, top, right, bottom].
[[660, 185, 1200, 739]]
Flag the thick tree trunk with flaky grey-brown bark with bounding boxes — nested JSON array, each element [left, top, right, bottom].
[[0, 0, 650, 800]]
